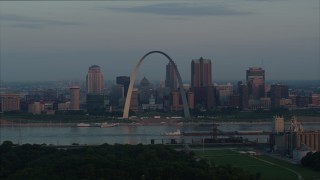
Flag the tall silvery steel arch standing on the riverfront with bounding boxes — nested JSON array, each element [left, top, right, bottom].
[[123, 51, 190, 119]]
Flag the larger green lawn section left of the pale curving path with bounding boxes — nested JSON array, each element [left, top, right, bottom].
[[196, 150, 298, 179]]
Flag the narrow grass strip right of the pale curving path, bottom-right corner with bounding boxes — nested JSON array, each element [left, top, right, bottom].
[[259, 155, 320, 180]]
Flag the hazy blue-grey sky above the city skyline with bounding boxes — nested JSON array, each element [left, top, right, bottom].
[[0, 0, 320, 81]]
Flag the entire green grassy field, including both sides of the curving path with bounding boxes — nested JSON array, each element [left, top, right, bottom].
[[196, 149, 320, 180]]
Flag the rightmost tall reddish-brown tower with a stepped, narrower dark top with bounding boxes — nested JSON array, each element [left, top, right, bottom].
[[246, 67, 265, 99]]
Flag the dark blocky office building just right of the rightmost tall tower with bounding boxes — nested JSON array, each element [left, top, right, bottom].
[[270, 84, 289, 108]]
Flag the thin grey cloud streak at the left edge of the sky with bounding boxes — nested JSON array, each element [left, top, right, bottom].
[[0, 14, 82, 28]]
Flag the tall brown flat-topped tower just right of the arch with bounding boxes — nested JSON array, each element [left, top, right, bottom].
[[191, 57, 212, 88]]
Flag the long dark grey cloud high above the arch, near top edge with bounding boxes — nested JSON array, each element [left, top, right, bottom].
[[104, 2, 253, 16]]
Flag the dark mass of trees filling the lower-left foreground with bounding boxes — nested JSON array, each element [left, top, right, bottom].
[[0, 141, 259, 180]]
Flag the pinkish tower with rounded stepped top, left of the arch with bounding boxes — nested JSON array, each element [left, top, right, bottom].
[[87, 65, 104, 94]]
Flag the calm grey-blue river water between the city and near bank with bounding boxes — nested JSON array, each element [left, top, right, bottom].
[[0, 123, 320, 145]]
